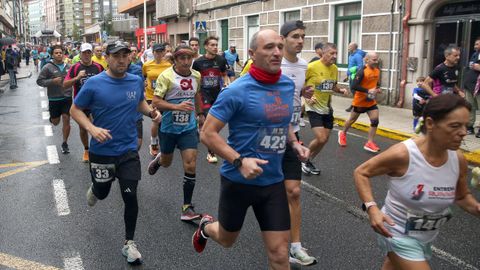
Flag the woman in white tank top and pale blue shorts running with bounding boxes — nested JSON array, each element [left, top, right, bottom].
[[354, 94, 480, 270]]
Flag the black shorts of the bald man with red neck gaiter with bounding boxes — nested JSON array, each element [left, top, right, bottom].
[[218, 176, 290, 232]]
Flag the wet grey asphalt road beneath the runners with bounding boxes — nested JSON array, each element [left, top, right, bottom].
[[0, 68, 480, 269]]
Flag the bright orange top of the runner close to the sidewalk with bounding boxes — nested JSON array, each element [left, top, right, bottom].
[[352, 65, 380, 108]]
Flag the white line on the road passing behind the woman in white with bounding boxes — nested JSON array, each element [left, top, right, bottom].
[[302, 180, 480, 270]]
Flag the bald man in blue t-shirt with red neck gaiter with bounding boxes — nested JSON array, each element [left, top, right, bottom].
[[192, 29, 309, 269]]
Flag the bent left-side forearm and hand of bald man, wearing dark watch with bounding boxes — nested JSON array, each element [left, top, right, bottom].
[[200, 114, 268, 179]]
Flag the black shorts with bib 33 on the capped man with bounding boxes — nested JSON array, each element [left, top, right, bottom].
[[89, 151, 142, 183]]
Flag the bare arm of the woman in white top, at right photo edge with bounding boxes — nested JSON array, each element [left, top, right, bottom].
[[455, 152, 480, 217]]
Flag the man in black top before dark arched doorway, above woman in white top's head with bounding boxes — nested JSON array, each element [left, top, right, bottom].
[[422, 46, 465, 97]]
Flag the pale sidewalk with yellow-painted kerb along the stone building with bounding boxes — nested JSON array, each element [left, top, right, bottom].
[[332, 96, 480, 165]]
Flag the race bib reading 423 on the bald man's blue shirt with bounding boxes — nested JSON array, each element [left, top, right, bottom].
[[257, 128, 288, 154]]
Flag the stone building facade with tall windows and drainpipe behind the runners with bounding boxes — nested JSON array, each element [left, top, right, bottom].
[[191, 0, 480, 107]]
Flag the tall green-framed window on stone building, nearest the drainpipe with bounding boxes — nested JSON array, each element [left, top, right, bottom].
[[334, 2, 362, 67]]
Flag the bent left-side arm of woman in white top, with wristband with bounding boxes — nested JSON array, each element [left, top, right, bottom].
[[353, 143, 409, 237]]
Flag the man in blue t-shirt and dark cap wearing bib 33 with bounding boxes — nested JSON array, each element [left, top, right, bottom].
[[70, 42, 160, 264]]
